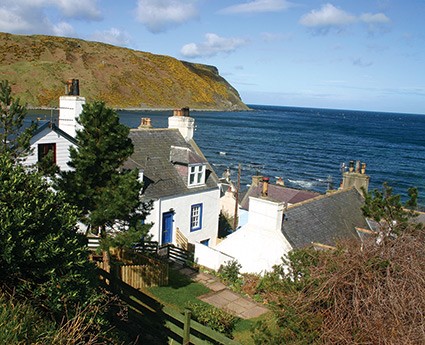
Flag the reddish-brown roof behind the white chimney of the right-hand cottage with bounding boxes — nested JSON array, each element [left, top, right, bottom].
[[241, 182, 320, 210]]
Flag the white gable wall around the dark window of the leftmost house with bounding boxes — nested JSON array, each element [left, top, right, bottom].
[[23, 128, 75, 171]]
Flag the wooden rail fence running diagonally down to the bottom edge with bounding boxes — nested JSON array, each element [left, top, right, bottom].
[[99, 269, 239, 345]]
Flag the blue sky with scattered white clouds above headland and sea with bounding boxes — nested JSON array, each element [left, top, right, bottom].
[[0, 0, 425, 114]]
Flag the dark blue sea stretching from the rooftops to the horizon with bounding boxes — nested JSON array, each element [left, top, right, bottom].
[[29, 105, 425, 208]]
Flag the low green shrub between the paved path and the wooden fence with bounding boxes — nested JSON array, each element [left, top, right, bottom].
[[187, 302, 238, 338]]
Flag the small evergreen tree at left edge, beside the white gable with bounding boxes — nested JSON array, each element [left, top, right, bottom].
[[0, 80, 36, 159]]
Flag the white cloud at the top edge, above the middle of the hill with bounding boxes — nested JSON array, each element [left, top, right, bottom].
[[136, 0, 198, 33]]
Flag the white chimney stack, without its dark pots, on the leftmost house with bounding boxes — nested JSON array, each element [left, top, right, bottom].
[[59, 96, 86, 138]]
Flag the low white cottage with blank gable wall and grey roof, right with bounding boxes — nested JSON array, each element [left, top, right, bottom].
[[207, 181, 368, 273]]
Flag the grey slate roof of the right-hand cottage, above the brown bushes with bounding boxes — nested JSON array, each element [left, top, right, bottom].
[[282, 188, 368, 248]]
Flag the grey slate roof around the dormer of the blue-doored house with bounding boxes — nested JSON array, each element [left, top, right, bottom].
[[124, 128, 218, 199]]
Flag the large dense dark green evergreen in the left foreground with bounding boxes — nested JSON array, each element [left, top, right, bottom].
[[0, 155, 98, 320]]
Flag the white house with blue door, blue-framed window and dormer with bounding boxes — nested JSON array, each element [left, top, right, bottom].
[[124, 109, 220, 246]]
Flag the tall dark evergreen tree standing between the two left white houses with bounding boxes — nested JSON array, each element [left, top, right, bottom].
[[58, 102, 148, 237]]
